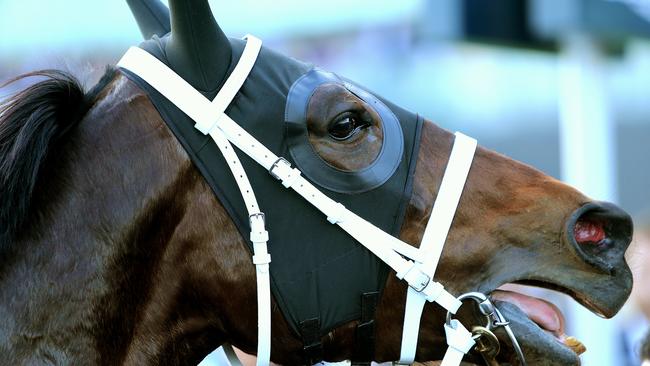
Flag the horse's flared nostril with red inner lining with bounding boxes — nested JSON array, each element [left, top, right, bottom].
[[567, 202, 632, 272]]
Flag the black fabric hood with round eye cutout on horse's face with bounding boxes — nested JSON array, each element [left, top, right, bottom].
[[123, 37, 422, 335]]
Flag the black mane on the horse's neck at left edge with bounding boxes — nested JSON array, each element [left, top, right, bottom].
[[0, 68, 116, 247]]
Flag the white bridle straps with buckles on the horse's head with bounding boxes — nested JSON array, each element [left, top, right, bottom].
[[117, 35, 476, 366]]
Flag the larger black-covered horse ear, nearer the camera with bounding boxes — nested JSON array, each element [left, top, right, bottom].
[[165, 0, 232, 91]]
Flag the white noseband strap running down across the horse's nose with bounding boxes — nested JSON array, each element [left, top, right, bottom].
[[399, 132, 476, 364]]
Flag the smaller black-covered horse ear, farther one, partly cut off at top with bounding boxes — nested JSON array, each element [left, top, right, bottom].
[[126, 0, 172, 39]]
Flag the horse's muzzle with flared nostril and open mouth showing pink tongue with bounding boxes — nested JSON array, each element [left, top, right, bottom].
[[474, 202, 633, 365]]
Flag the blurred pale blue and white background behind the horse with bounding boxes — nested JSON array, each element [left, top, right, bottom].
[[0, 0, 650, 366]]
